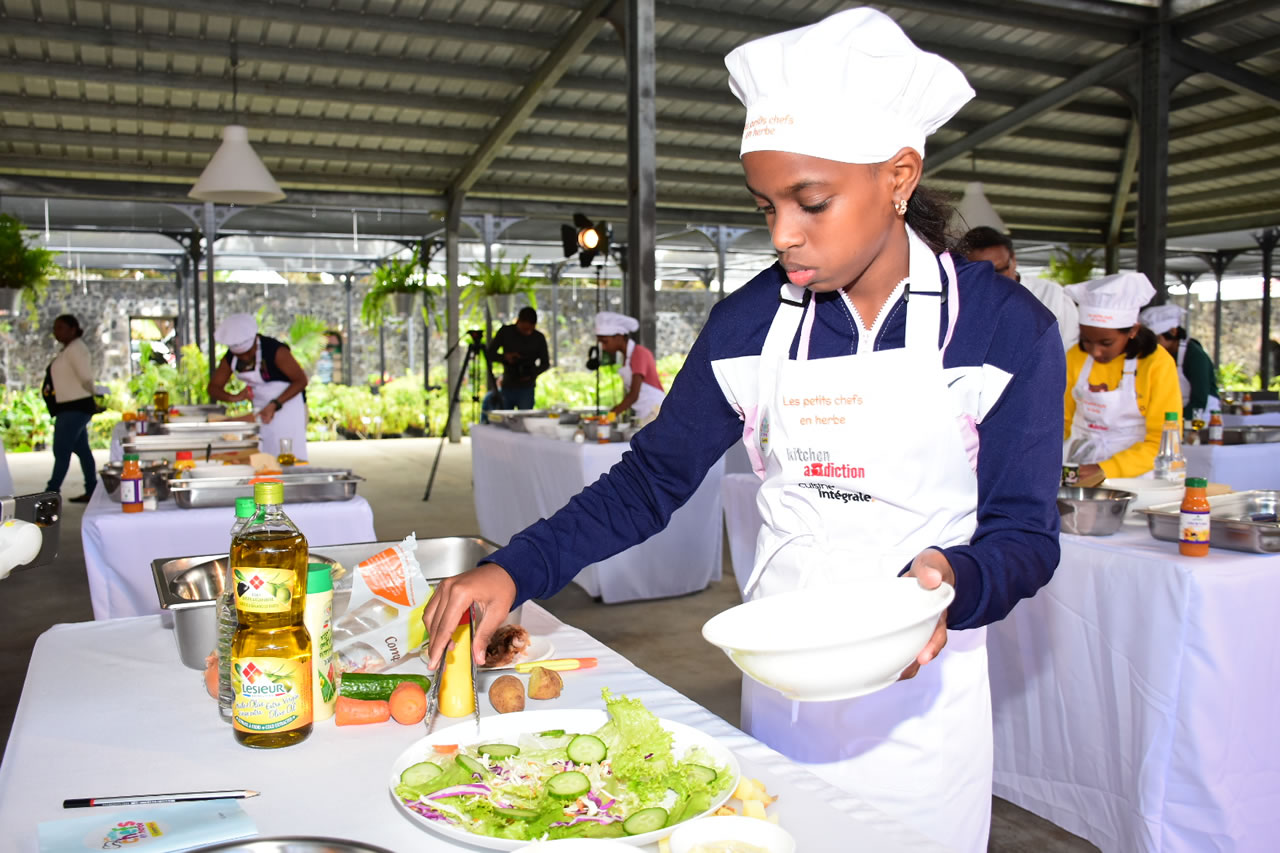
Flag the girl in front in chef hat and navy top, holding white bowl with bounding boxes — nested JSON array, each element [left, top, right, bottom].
[[425, 9, 1065, 850]]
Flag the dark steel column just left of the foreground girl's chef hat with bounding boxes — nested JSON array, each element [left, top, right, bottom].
[[622, 0, 658, 350]]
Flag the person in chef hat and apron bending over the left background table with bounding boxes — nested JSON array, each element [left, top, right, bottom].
[[209, 314, 307, 460]]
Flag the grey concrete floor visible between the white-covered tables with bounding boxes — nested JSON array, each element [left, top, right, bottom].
[[0, 439, 1097, 853]]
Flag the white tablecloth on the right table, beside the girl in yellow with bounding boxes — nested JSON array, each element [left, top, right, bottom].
[[987, 523, 1280, 853]]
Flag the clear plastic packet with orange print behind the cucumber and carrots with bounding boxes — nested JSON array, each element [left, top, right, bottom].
[[333, 533, 433, 672]]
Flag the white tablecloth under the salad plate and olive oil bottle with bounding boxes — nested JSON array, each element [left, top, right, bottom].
[[0, 605, 942, 853]]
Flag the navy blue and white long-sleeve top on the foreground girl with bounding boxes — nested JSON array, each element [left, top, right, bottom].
[[486, 261, 1066, 629]]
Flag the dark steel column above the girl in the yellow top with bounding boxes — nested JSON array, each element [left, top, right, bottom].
[[1138, 19, 1174, 305]]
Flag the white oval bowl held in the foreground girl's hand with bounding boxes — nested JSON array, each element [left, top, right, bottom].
[[703, 578, 955, 702]]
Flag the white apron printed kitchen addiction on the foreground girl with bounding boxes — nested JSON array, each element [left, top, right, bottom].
[[742, 231, 992, 852]]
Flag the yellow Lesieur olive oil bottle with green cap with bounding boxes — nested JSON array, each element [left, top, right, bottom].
[[230, 482, 312, 749]]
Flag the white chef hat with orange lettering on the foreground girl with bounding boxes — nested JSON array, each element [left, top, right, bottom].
[[724, 9, 974, 163]]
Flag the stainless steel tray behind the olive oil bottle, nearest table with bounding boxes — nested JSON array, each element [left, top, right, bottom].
[[151, 537, 499, 670]]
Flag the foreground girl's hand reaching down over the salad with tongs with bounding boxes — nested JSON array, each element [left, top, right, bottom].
[[422, 562, 516, 672]]
